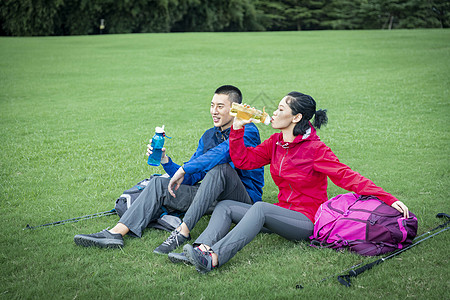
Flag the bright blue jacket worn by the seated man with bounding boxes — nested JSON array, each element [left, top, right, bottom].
[[162, 123, 264, 202]]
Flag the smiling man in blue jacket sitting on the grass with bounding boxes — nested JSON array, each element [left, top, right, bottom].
[[74, 85, 264, 254]]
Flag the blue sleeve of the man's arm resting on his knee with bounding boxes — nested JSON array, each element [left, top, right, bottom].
[[183, 124, 260, 174]]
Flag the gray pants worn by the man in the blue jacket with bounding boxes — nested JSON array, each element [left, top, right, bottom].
[[119, 164, 252, 237]]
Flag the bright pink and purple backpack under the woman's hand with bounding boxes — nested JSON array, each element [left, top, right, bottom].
[[310, 193, 418, 256]]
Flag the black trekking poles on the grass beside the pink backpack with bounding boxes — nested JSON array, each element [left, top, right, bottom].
[[337, 213, 450, 287]]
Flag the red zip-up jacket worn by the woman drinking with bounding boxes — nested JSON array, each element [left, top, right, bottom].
[[229, 126, 398, 222]]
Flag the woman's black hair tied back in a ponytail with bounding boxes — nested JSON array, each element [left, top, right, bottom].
[[286, 92, 328, 136]]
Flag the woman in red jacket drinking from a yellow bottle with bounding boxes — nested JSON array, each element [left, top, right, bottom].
[[171, 92, 409, 273]]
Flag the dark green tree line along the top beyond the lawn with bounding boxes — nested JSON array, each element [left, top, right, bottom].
[[0, 0, 450, 36]]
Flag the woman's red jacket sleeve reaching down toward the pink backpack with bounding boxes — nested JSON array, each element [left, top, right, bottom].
[[314, 144, 398, 205]]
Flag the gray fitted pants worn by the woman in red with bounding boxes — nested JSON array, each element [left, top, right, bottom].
[[194, 200, 314, 266]]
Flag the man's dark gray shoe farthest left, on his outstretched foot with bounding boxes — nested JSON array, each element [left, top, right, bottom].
[[73, 229, 123, 248]]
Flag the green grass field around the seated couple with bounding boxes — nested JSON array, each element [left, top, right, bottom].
[[0, 30, 450, 299]]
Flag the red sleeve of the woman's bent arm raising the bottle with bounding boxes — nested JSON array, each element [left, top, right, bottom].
[[229, 127, 272, 170]]
